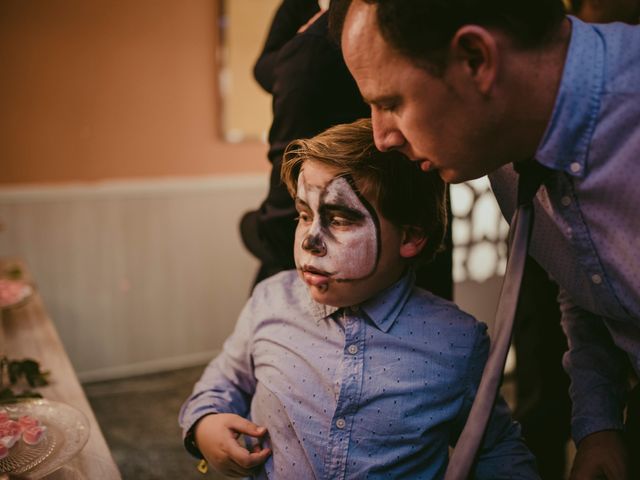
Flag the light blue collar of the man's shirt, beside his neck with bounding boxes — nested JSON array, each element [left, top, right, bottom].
[[535, 16, 605, 177]]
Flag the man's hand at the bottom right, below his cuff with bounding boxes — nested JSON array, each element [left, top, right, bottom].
[[571, 430, 629, 480]]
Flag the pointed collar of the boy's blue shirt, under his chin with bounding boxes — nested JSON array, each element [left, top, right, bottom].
[[304, 269, 415, 332]]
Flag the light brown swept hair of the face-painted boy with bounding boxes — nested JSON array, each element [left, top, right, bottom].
[[281, 118, 447, 262]]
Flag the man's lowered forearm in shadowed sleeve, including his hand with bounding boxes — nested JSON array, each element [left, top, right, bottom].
[[558, 291, 628, 480]]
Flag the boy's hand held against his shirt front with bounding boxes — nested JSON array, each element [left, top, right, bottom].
[[195, 413, 271, 477]]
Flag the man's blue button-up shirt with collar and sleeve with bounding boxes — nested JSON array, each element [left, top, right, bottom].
[[490, 17, 640, 442]]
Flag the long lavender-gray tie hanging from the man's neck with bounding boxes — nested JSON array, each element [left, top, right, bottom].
[[444, 160, 551, 480]]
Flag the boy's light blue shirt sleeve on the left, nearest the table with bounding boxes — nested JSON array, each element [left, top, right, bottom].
[[179, 297, 256, 456]]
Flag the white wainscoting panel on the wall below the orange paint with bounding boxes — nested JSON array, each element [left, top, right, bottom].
[[0, 175, 268, 381]]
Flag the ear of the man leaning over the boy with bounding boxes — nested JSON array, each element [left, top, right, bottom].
[[451, 25, 499, 95]]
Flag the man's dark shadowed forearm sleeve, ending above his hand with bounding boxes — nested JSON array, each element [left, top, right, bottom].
[[558, 290, 628, 444]]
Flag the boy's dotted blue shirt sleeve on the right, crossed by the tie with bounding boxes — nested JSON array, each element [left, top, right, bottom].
[[452, 324, 540, 480]]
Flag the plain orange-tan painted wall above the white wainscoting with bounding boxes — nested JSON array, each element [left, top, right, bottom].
[[0, 0, 268, 185]]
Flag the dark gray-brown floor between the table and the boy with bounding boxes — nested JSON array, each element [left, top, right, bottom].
[[83, 366, 226, 480]]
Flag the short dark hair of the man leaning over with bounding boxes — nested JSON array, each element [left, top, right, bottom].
[[329, 0, 565, 74]]
